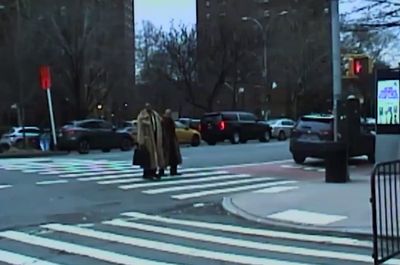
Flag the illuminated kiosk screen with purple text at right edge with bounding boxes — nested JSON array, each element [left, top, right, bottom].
[[377, 80, 400, 125]]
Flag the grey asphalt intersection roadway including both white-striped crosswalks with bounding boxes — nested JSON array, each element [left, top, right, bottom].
[[0, 141, 376, 265]]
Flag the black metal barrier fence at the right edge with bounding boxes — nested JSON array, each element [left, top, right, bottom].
[[371, 160, 400, 264]]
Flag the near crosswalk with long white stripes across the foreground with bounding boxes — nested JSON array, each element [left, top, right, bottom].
[[0, 212, 394, 265]]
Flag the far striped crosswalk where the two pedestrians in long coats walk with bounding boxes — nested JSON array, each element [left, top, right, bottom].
[[0, 159, 297, 200]]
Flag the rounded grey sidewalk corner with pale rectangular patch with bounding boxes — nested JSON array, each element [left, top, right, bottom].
[[222, 169, 372, 235]]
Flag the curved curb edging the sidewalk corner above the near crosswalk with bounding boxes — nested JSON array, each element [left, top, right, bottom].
[[221, 197, 372, 238]]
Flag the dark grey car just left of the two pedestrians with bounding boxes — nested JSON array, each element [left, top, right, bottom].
[[58, 119, 133, 154]]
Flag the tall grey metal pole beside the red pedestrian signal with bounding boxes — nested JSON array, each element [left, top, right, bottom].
[[331, 0, 342, 142]]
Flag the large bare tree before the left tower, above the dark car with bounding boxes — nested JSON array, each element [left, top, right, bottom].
[[35, 0, 127, 118]]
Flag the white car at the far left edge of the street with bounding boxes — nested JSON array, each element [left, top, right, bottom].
[[0, 126, 41, 150]]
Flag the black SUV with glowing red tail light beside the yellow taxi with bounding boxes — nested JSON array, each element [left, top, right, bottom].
[[200, 111, 271, 145]]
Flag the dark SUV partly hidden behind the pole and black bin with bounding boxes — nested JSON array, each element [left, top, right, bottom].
[[290, 115, 375, 164]]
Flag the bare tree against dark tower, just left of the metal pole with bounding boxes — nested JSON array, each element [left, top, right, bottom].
[[271, 5, 331, 117]]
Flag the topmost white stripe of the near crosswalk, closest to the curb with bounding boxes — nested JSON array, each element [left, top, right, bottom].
[[121, 212, 372, 249]]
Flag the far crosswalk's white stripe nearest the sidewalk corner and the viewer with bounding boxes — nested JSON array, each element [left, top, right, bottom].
[[171, 180, 296, 200]]
